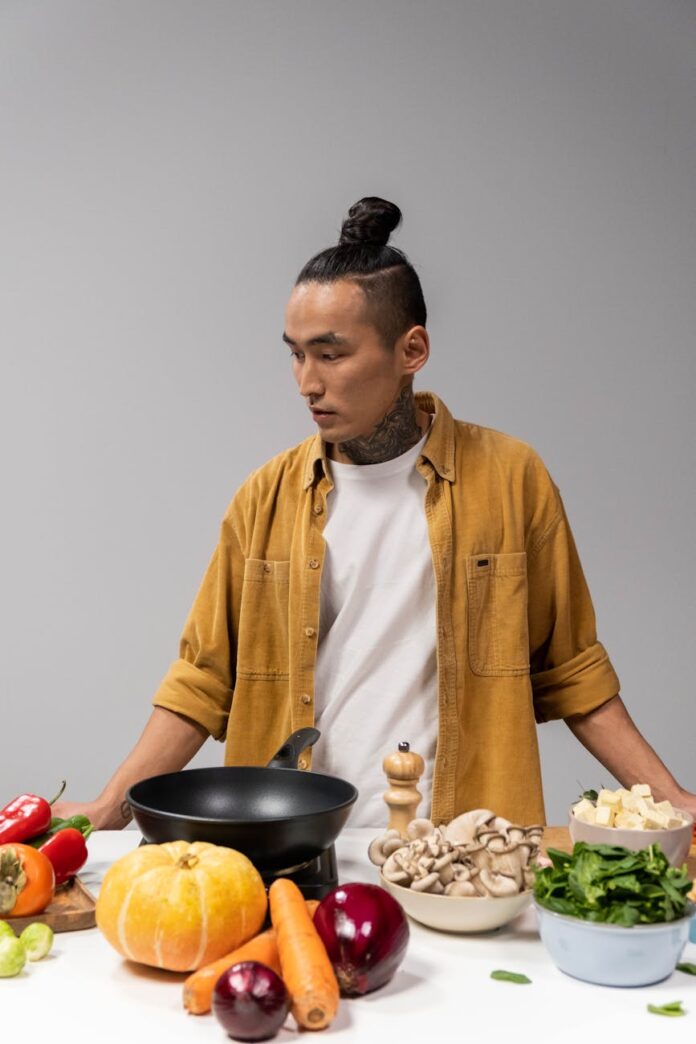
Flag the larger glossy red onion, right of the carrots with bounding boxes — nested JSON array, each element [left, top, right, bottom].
[[314, 882, 409, 997]]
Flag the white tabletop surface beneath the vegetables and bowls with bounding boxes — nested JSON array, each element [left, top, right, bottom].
[[0, 829, 696, 1044]]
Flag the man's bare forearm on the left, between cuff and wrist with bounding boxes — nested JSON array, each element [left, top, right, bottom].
[[94, 707, 208, 830]]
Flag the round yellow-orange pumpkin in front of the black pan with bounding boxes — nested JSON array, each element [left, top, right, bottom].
[[95, 841, 268, 972]]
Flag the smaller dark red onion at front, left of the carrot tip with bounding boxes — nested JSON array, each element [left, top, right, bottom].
[[213, 960, 290, 1041]]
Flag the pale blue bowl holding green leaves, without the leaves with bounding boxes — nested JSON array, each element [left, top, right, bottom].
[[534, 902, 694, 986]]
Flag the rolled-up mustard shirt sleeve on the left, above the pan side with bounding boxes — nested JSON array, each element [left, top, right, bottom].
[[152, 520, 243, 740]]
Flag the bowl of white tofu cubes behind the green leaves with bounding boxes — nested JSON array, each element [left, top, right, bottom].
[[569, 783, 694, 867]]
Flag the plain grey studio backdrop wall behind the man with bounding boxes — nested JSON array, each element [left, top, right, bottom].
[[0, 0, 696, 822]]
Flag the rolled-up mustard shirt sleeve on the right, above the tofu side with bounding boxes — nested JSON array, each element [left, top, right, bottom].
[[527, 497, 620, 721]]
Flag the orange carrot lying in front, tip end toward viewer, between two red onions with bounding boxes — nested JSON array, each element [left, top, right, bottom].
[[268, 877, 338, 1029]]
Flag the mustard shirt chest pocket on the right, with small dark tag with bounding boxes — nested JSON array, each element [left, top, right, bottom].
[[466, 551, 529, 678]]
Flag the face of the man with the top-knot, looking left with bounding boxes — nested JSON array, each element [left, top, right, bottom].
[[283, 280, 408, 444]]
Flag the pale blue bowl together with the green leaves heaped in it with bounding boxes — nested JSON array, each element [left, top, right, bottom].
[[534, 841, 696, 987]]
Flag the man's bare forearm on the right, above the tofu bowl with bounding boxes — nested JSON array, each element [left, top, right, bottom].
[[566, 696, 693, 807]]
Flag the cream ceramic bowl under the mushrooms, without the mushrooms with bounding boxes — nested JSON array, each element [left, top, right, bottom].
[[380, 874, 532, 932]]
